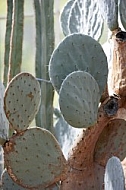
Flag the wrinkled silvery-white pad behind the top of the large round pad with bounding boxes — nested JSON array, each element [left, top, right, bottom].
[[68, 0, 103, 40]]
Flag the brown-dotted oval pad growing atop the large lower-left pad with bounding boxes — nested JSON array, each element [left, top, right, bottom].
[[4, 73, 41, 131]]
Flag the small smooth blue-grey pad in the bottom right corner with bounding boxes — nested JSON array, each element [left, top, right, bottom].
[[104, 156, 125, 190]]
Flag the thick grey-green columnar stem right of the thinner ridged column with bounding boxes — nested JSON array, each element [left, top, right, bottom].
[[34, 0, 54, 132]]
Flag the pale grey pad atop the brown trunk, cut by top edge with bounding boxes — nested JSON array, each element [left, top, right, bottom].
[[97, 0, 118, 31]]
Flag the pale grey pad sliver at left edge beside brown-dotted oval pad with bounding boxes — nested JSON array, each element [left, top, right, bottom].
[[0, 82, 9, 145]]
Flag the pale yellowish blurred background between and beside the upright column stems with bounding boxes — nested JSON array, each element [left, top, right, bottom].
[[0, 0, 67, 80]]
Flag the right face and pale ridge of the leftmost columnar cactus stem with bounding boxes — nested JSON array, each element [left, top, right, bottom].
[[8, 0, 24, 81]]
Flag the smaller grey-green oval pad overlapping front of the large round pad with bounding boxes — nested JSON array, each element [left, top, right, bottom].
[[59, 71, 100, 128]]
